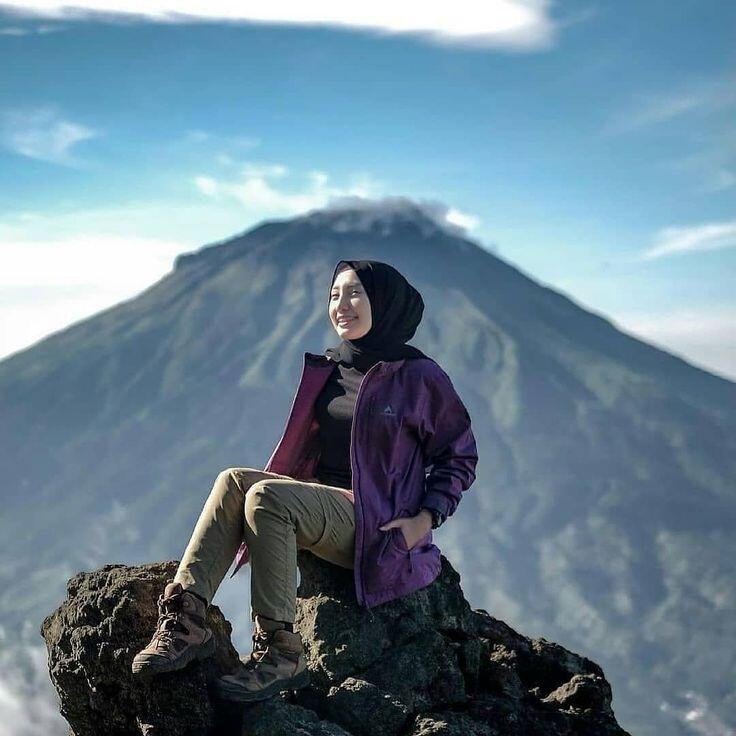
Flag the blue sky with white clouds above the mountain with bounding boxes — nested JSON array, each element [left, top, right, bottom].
[[0, 0, 736, 379]]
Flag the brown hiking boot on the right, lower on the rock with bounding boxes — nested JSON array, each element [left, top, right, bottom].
[[215, 622, 309, 703]]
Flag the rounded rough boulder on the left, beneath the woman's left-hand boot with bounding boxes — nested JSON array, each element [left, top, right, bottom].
[[41, 562, 238, 736]]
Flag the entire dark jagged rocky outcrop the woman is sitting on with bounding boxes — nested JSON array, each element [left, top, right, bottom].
[[41, 551, 626, 736]]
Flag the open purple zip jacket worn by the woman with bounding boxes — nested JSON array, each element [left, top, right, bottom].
[[232, 352, 478, 608]]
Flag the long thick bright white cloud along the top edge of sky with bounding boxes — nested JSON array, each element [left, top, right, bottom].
[[0, 0, 556, 51]]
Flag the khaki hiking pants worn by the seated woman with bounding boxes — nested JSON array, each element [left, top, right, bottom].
[[174, 468, 355, 623]]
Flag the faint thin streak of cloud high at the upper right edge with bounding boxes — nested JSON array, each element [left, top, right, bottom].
[[603, 78, 736, 135]]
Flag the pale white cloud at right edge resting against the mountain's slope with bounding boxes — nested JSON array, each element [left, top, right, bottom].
[[615, 306, 736, 381]]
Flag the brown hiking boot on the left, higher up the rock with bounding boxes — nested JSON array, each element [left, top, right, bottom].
[[132, 583, 215, 675]]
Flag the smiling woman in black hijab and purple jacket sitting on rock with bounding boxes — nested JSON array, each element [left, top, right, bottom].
[[133, 261, 478, 702]]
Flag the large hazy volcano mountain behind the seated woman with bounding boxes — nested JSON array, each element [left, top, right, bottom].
[[0, 199, 736, 736]]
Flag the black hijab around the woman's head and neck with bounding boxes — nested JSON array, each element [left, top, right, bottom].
[[324, 261, 427, 373]]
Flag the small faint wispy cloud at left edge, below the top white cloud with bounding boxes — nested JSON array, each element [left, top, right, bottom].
[[0, 106, 99, 166]]
